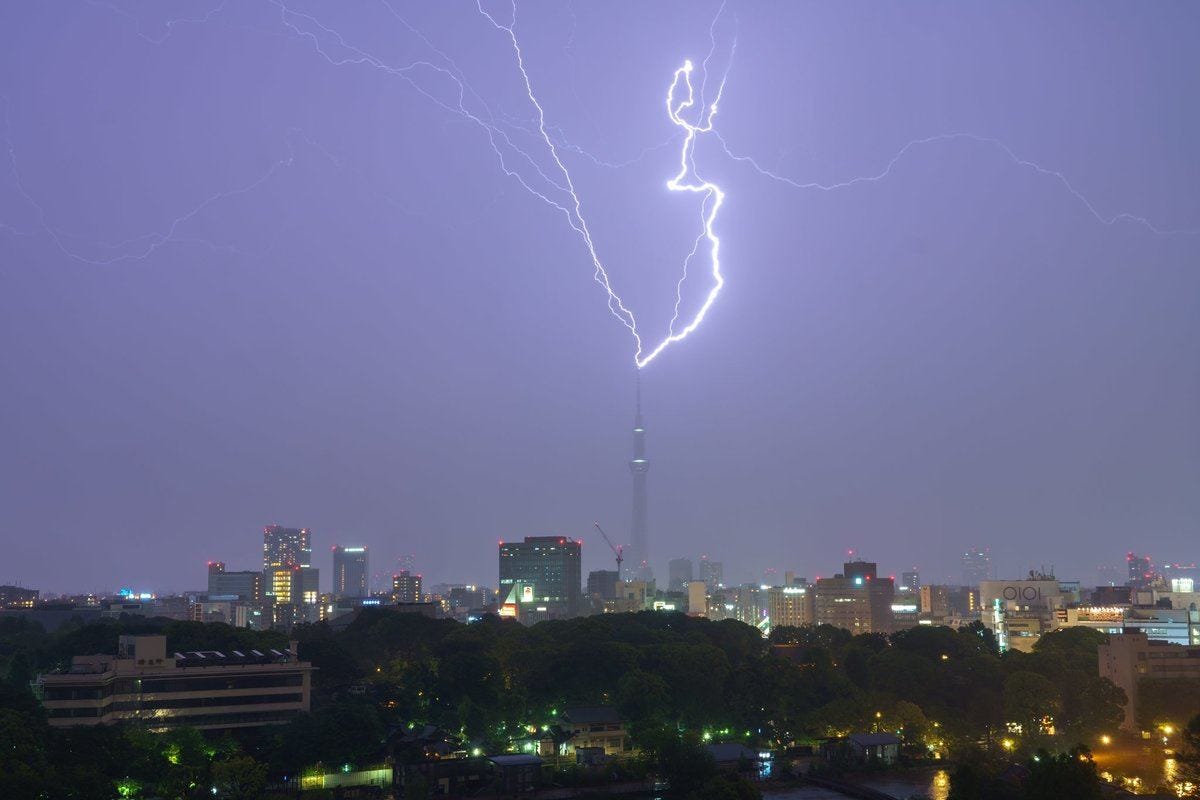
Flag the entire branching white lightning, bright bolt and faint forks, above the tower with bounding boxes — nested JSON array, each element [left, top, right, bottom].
[[9, 0, 1200, 369]]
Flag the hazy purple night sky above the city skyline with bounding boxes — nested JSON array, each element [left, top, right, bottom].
[[0, 0, 1200, 591]]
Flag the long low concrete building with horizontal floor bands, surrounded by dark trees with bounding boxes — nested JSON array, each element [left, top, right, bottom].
[[35, 636, 312, 730]]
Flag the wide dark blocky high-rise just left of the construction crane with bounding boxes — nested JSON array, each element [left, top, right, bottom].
[[499, 536, 583, 616]]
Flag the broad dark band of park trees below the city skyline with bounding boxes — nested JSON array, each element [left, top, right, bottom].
[[0, 609, 1124, 798]]
